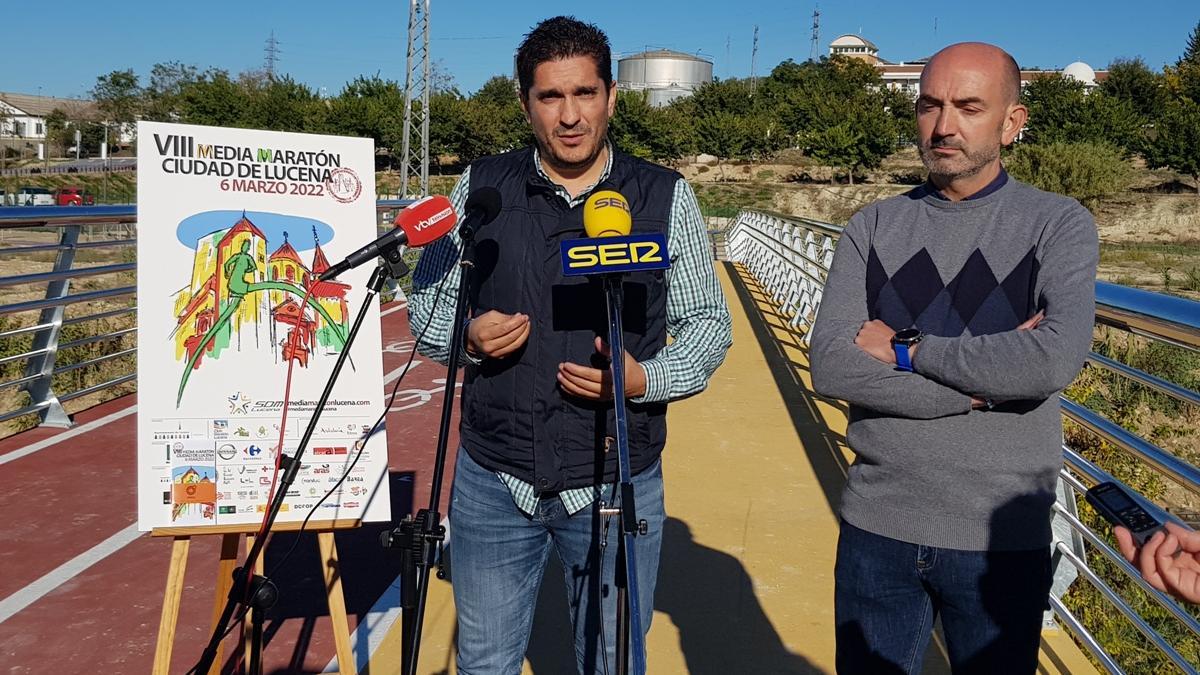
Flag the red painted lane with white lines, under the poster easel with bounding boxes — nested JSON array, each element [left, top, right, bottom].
[[0, 300, 457, 673]]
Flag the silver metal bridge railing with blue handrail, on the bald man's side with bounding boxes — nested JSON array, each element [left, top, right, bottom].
[[726, 210, 1200, 674]]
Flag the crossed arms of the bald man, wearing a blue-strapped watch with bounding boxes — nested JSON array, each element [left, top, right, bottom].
[[811, 208, 1098, 419]]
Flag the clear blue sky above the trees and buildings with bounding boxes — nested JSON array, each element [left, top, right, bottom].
[[11, 0, 1200, 97]]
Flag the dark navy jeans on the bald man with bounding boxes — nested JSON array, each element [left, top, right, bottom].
[[834, 521, 1051, 675]]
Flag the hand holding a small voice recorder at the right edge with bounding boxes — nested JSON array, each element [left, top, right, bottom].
[[1114, 522, 1200, 603]]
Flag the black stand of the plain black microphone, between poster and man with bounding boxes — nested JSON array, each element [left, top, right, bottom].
[[379, 220, 478, 675]]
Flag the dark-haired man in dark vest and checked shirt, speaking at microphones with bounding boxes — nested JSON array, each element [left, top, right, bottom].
[[409, 17, 731, 674]]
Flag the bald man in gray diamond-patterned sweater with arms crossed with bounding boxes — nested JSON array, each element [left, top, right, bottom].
[[811, 43, 1098, 674]]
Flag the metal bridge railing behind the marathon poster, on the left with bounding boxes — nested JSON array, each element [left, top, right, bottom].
[[0, 199, 412, 426]]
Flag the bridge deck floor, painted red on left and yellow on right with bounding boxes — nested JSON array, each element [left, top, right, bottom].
[[0, 265, 1093, 674]]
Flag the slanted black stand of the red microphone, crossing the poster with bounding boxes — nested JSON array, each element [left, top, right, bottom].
[[192, 249, 407, 675]]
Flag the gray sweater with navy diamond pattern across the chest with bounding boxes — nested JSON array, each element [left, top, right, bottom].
[[811, 179, 1098, 550]]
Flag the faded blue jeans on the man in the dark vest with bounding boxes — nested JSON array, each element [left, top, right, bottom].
[[450, 449, 666, 675]]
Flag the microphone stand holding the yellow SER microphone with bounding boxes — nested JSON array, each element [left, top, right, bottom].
[[596, 274, 647, 675]]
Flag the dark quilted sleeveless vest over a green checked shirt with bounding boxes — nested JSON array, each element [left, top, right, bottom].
[[462, 148, 680, 492]]
